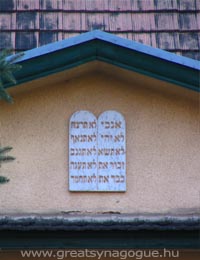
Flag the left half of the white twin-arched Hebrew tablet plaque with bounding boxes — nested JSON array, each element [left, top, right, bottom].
[[69, 111, 98, 191]]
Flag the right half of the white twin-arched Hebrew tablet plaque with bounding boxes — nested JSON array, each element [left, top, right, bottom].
[[97, 111, 126, 191]]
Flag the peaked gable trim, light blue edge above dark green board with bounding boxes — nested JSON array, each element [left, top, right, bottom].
[[6, 30, 200, 92]]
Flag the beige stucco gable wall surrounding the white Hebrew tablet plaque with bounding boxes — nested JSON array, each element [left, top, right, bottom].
[[0, 63, 200, 214]]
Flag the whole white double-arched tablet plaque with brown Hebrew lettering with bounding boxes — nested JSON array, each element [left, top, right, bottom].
[[69, 111, 126, 191]]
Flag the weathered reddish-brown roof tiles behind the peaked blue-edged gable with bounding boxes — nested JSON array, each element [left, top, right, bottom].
[[0, 0, 200, 59]]
